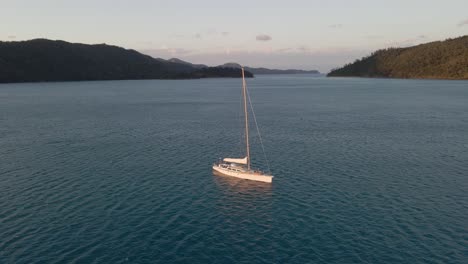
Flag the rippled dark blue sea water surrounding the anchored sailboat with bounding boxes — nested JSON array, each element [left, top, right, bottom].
[[0, 75, 468, 263]]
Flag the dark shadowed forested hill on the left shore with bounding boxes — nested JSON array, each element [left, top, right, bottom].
[[0, 39, 253, 83]]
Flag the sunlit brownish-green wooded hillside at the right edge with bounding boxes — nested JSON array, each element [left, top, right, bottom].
[[327, 36, 468, 79]]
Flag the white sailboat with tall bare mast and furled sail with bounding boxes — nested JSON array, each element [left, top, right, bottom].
[[213, 67, 273, 183]]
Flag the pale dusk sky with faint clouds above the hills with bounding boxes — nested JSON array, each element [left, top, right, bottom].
[[0, 0, 468, 72]]
